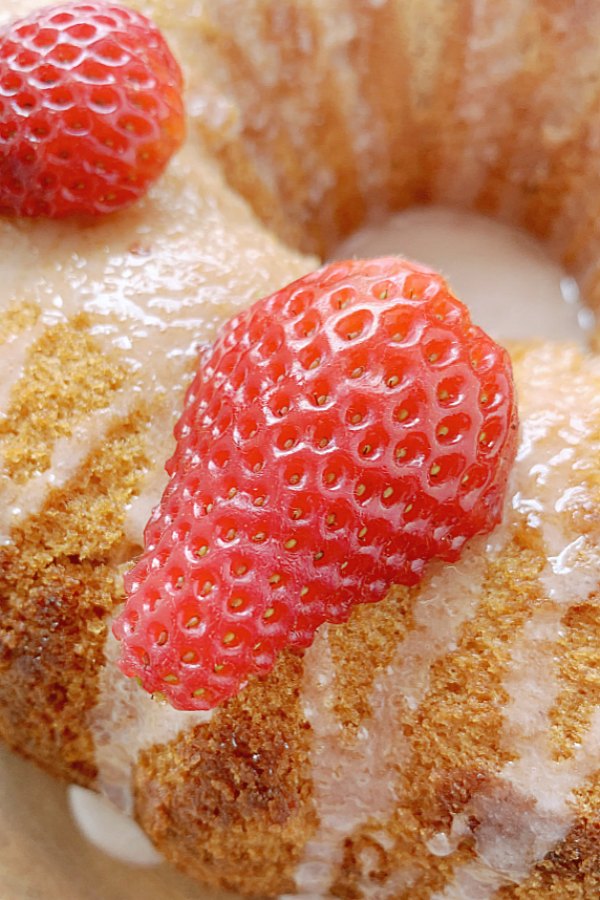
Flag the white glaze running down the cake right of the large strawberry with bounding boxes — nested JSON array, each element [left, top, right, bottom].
[[288, 344, 600, 900]]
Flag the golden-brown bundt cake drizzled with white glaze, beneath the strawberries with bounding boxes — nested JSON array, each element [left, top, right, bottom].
[[0, 0, 600, 900]]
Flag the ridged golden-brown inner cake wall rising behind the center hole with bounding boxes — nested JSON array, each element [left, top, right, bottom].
[[188, 0, 600, 330]]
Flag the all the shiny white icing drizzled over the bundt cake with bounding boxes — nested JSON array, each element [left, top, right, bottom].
[[0, 0, 600, 900]]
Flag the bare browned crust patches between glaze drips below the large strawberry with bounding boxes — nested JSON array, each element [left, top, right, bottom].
[[130, 532, 600, 900]]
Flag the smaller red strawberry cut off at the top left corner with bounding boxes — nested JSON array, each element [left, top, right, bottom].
[[0, 0, 185, 218]]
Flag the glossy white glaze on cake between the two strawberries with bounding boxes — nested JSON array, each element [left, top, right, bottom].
[[0, 146, 311, 544]]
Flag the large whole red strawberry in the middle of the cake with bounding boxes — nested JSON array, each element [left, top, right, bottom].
[[114, 258, 517, 709]]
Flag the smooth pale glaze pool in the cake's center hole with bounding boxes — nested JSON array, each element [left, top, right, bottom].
[[334, 206, 594, 346]]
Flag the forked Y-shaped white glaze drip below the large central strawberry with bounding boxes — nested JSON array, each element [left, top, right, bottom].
[[295, 540, 494, 897]]
